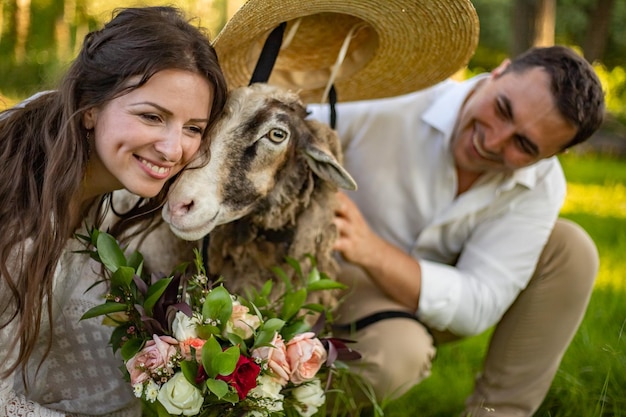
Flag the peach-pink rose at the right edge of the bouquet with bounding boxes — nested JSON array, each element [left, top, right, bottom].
[[287, 332, 327, 385]]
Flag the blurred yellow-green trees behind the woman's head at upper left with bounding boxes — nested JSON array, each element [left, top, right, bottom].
[[0, 0, 230, 99]]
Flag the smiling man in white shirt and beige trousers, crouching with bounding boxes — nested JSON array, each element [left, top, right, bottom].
[[311, 46, 604, 416]]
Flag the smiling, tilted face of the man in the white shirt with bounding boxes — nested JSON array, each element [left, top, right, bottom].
[[451, 62, 576, 175]]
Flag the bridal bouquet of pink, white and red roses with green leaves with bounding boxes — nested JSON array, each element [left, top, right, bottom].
[[79, 229, 360, 417]]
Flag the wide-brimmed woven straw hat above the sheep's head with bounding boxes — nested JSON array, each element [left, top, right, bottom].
[[214, 0, 479, 103]]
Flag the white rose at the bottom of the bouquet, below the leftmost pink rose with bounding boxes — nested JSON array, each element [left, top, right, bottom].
[[157, 372, 204, 416]]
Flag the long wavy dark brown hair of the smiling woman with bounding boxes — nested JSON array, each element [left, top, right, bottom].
[[0, 7, 226, 374]]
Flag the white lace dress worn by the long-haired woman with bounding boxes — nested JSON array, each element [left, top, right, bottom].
[[0, 234, 141, 417]]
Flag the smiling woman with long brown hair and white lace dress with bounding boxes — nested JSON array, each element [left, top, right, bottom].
[[0, 7, 226, 416]]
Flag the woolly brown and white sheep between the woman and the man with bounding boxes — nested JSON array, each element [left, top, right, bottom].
[[129, 83, 356, 304]]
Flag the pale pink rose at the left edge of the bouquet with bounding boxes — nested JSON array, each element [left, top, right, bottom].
[[126, 335, 178, 385]]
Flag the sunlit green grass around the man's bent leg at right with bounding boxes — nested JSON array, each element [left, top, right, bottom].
[[384, 154, 626, 417]]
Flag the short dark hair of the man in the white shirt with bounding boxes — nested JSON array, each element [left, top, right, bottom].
[[504, 46, 605, 149]]
